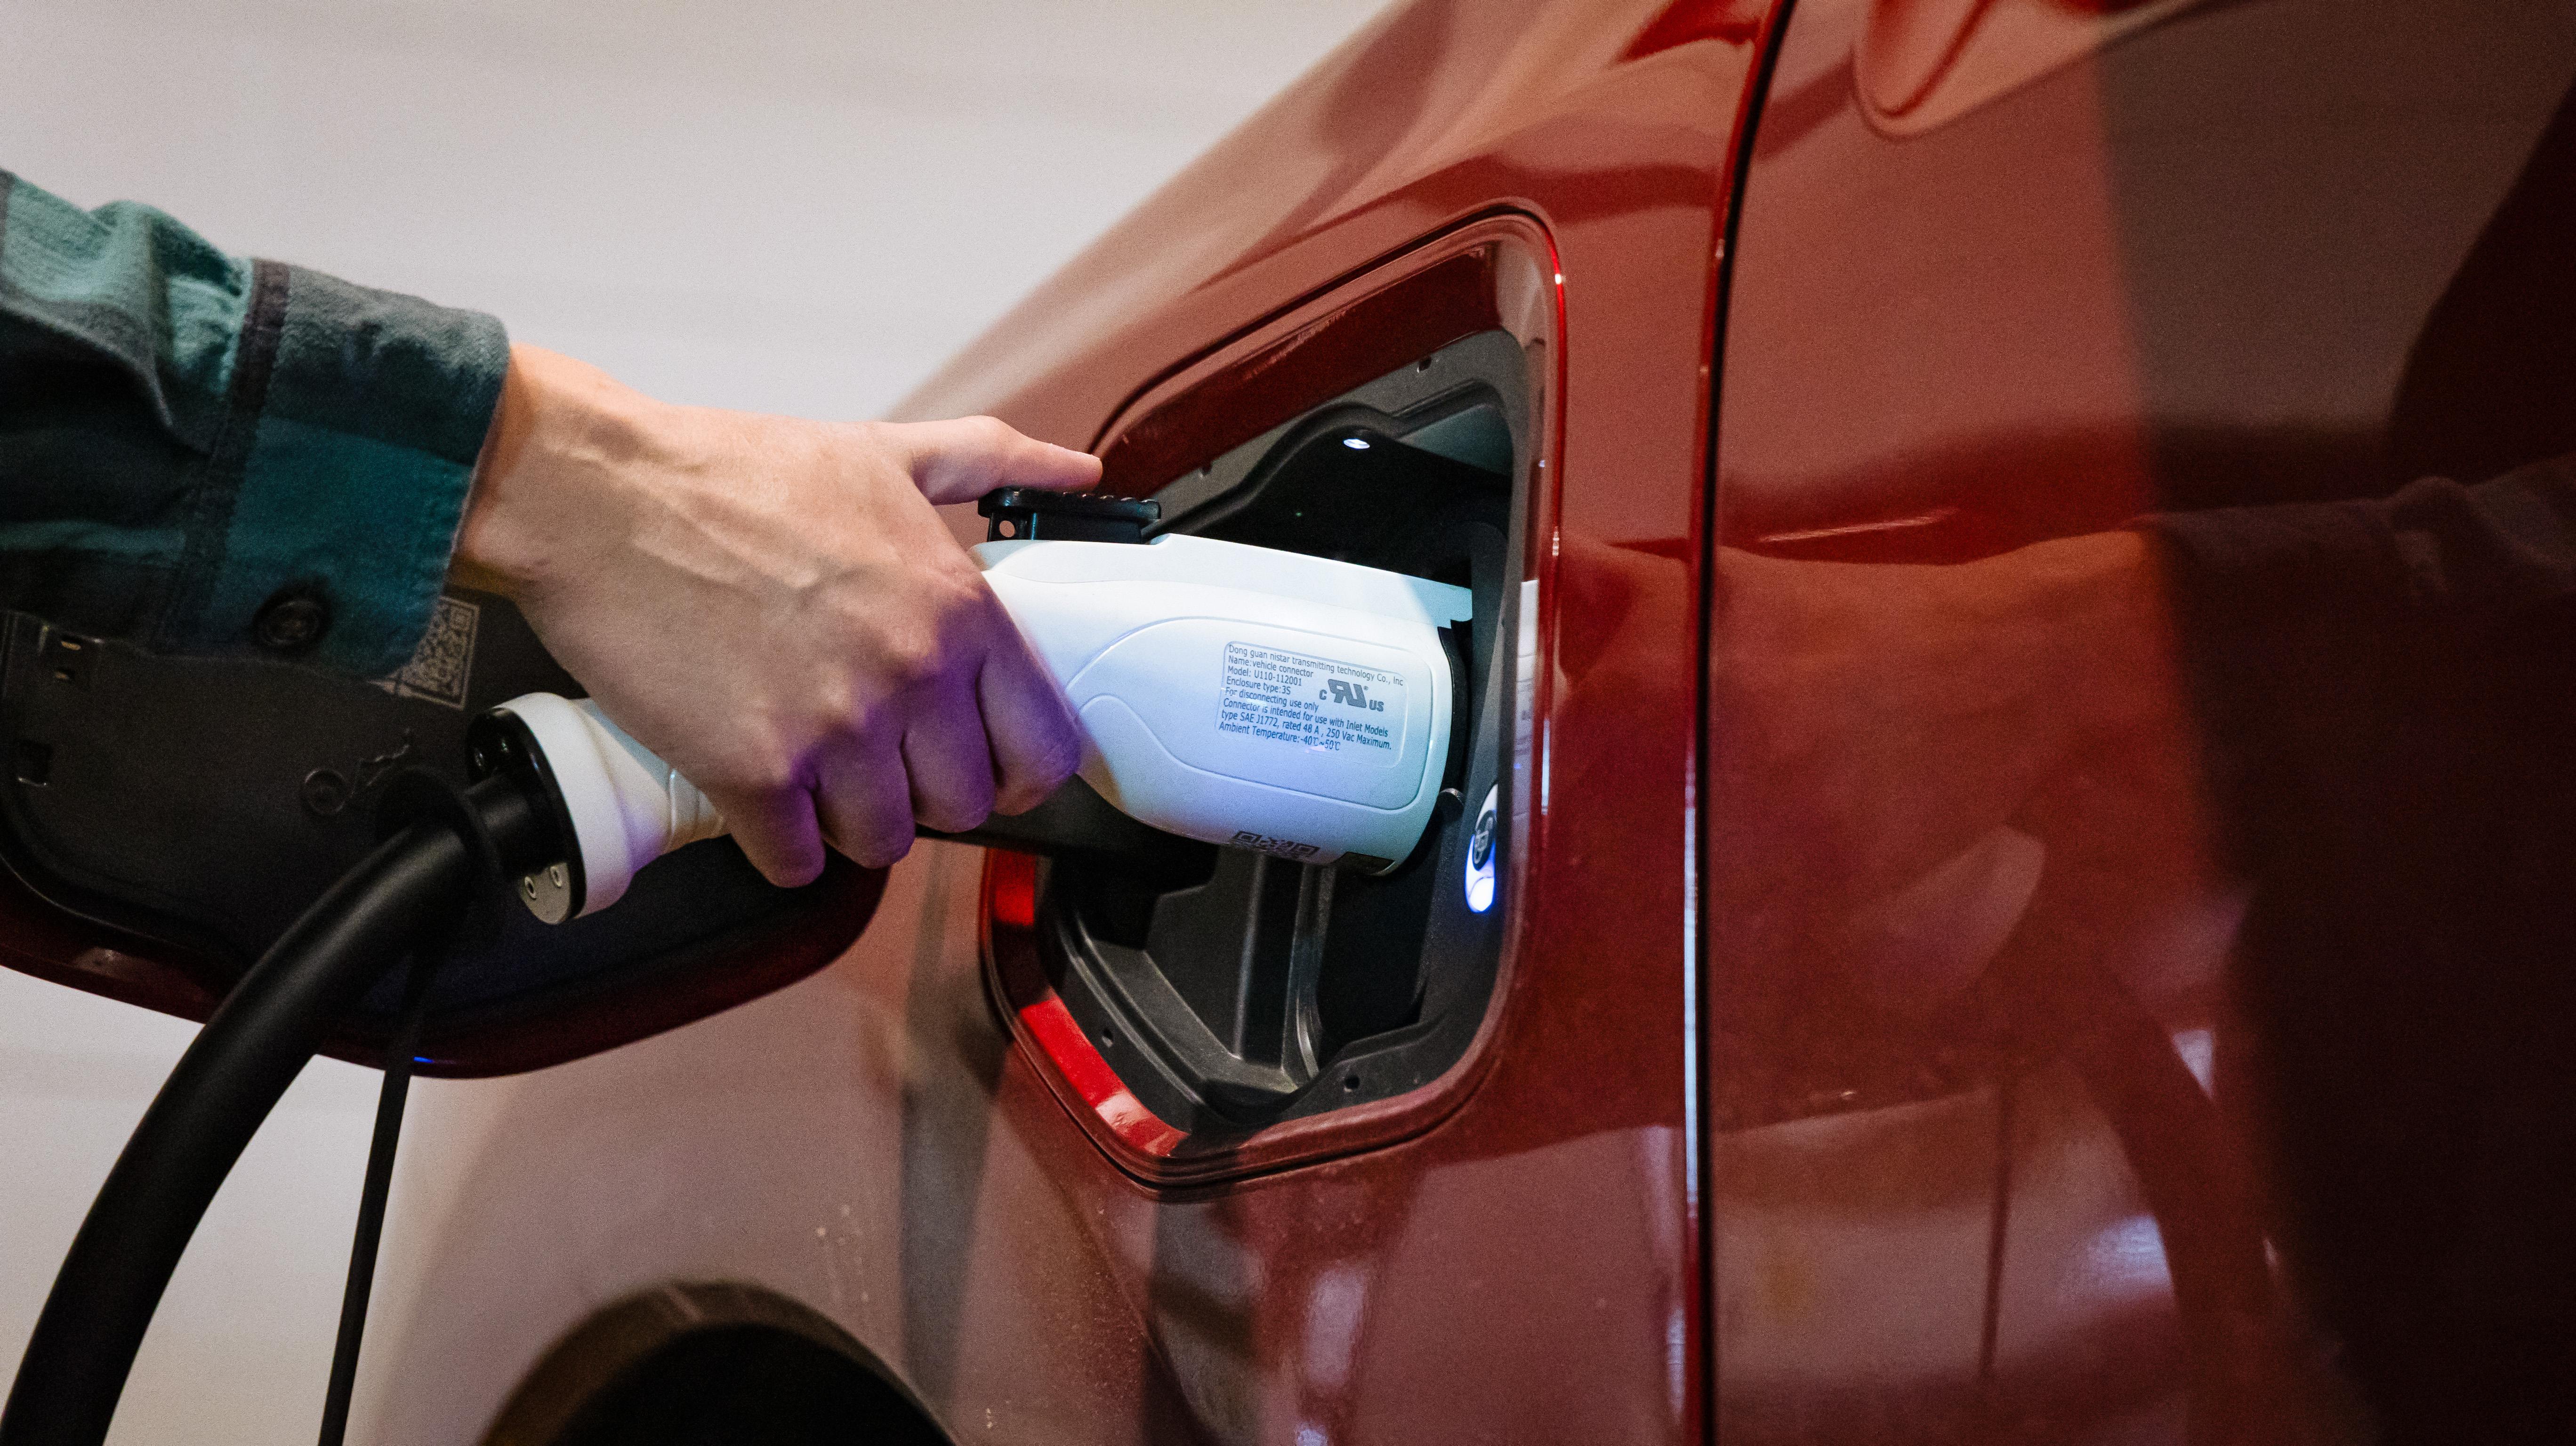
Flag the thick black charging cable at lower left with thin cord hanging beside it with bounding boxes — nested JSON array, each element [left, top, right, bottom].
[[0, 773, 559, 1446]]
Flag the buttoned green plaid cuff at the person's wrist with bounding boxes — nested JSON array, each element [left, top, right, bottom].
[[160, 260, 510, 678]]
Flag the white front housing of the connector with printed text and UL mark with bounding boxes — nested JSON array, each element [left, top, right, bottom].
[[974, 536, 1473, 871]]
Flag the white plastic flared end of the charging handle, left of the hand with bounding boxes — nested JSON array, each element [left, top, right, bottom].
[[495, 693, 724, 917]]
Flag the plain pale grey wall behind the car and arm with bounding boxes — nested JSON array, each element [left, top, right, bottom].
[[0, 0, 1378, 1446]]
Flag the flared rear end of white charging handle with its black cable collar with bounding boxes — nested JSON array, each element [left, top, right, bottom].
[[466, 693, 726, 923]]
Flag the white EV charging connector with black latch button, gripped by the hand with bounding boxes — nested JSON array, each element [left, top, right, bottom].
[[469, 490, 1473, 923]]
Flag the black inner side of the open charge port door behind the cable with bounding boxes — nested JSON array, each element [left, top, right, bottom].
[[0, 590, 881, 1075]]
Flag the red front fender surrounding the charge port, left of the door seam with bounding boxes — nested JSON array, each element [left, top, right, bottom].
[[378, 2, 1759, 1441]]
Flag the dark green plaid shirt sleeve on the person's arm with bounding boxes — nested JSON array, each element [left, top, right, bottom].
[[0, 170, 510, 678]]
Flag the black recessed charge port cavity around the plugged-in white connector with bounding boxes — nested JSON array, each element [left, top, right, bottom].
[[1038, 332, 1528, 1137]]
